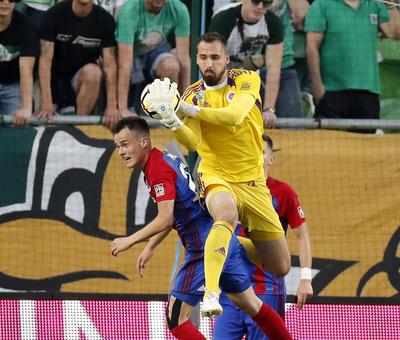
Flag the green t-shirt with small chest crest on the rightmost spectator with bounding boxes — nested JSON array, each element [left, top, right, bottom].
[[305, 0, 389, 94]]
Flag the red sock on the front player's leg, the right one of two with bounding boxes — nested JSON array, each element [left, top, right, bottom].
[[252, 303, 293, 340]]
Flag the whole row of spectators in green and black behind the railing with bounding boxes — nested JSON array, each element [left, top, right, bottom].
[[0, 0, 400, 127]]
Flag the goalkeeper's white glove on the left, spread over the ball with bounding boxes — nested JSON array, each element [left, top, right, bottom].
[[149, 78, 178, 115]]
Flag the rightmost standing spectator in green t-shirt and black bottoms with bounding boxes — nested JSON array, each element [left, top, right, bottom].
[[306, 0, 400, 119]]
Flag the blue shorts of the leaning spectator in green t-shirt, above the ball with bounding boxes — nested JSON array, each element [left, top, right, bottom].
[[131, 42, 172, 84]]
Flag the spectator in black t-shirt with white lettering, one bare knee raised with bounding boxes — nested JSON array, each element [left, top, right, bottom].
[[38, 0, 119, 126]]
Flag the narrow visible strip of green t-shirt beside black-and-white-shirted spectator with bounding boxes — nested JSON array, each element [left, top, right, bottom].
[[268, 0, 294, 69]]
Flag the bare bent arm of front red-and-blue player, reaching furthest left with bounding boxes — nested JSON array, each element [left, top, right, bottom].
[[111, 200, 175, 256]]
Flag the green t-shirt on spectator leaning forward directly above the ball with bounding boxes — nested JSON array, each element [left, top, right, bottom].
[[116, 0, 190, 55]]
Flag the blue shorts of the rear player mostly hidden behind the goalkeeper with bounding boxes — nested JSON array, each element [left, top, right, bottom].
[[212, 294, 286, 340]]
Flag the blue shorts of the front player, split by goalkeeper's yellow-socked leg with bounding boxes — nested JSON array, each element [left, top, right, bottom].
[[171, 237, 251, 306]]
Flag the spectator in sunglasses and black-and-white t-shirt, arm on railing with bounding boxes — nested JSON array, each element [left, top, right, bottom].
[[209, 0, 283, 127]]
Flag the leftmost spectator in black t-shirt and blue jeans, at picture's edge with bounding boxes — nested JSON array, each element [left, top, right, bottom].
[[0, 0, 40, 125]]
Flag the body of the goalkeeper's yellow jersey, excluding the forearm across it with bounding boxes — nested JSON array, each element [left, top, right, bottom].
[[182, 69, 264, 182]]
